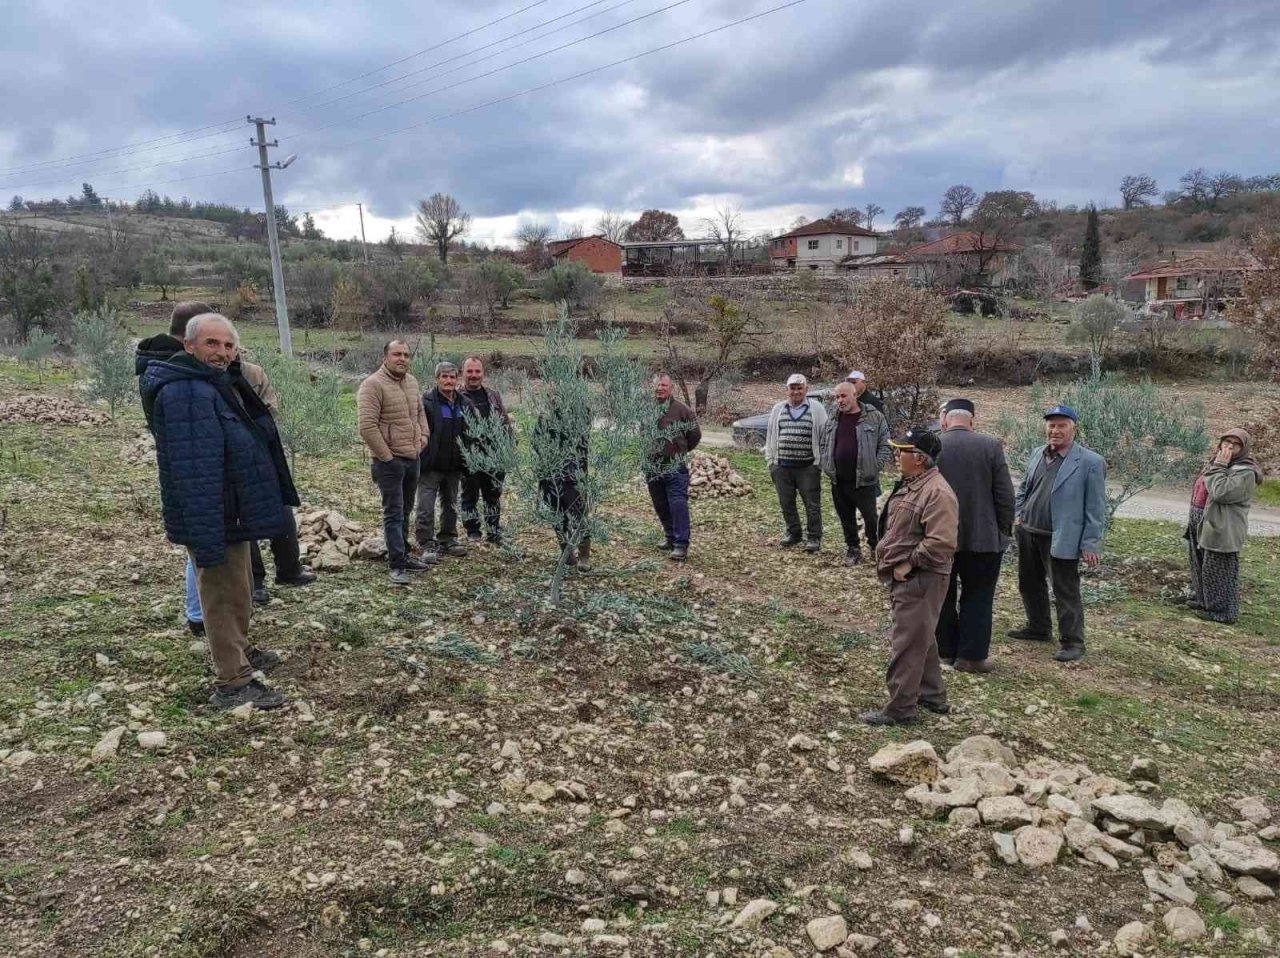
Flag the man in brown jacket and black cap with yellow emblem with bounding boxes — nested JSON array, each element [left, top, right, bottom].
[[861, 426, 960, 725]]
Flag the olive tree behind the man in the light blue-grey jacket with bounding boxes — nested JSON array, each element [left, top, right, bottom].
[[1000, 357, 1208, 524]]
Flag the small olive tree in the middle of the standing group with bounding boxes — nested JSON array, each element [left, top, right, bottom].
[[463, 307, 673, 606]]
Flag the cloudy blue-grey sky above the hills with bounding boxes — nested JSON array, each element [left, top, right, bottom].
[[0, 0, 1280, 243]]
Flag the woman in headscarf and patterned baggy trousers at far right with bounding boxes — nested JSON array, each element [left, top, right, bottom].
[[1184, 429, 1262, 625]]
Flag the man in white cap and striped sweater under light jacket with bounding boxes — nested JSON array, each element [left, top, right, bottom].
[[764, 373, 827, 552]]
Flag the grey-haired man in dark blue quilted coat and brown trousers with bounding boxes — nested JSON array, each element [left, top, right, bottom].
[[141, 313, 297, 708]]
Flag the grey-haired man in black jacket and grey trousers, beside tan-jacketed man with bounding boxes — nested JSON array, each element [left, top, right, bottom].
[[413, 362, 474, 564]]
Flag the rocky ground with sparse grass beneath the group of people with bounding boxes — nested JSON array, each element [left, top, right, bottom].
[[0, 366, 1280, 958]]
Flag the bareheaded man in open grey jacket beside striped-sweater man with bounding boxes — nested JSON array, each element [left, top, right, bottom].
[[818, 382, 893, 566]]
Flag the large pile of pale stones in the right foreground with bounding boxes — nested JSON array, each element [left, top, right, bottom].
[[869, 735, 1280, 937]]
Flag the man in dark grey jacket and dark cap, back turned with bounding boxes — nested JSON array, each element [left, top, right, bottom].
[[937, 400, 1014, 672]]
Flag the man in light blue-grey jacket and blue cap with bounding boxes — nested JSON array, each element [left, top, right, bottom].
[[1009, 406, 1107, 662]]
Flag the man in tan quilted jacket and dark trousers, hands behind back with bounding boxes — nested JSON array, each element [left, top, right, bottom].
[[356, 339, 428, 585]]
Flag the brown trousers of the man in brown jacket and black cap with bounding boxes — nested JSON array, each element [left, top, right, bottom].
[[884, 571, 947, 719]]
